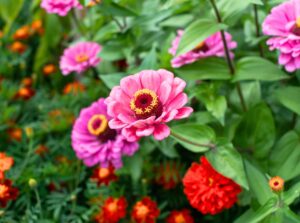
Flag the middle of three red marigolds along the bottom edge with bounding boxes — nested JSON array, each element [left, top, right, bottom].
[[131, 197, 160, 223]]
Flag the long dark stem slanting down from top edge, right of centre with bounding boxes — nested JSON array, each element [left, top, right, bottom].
[[210, 0, 247, 112]]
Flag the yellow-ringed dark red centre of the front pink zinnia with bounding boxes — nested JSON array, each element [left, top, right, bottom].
[[130, 89, 160, 118]]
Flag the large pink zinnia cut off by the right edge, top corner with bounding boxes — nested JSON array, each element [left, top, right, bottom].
[[263, 0, 300, 72]]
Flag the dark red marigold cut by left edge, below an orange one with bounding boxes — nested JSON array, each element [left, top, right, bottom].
[[0, 179, 19, 207]]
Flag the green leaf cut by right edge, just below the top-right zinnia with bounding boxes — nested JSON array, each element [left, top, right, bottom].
[[275, 87, 300, 115]]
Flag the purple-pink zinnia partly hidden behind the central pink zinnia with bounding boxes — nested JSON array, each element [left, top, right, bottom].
[[71, 98, 138, 168]]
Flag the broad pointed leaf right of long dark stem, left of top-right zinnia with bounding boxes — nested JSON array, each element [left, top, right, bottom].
[[233, 57, 288, 81]]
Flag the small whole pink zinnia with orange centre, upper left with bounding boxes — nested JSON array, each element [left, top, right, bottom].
[[60, 42, 101, 75]]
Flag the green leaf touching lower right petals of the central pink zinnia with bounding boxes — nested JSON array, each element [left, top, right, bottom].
[[172, 124, 216, 153]]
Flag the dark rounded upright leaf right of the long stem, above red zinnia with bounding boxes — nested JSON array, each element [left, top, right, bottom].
[[234, 103, 275, 158]]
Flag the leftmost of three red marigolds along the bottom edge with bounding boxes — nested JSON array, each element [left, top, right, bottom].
[[94, 197, 127, 223]]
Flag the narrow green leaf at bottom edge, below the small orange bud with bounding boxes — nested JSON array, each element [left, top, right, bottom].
[[234, 198, 279, 223]]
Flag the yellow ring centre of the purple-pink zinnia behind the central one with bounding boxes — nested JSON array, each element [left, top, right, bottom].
[[87, 114, 108, 136]]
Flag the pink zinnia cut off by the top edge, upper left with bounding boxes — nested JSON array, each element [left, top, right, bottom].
[[41, 0, 82, 16]]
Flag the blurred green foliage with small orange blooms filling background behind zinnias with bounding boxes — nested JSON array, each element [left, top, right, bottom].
[[0, 0, 300, 223]]
